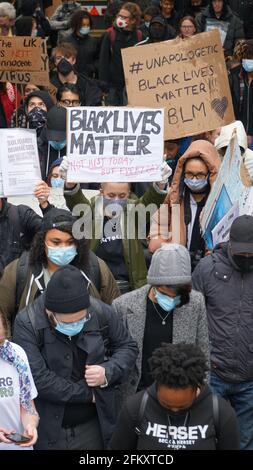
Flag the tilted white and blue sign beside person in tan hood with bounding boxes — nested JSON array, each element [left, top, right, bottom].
[[200, 135, 253, 249]]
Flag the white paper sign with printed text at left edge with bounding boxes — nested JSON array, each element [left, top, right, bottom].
[[0, 129, 41, 197]]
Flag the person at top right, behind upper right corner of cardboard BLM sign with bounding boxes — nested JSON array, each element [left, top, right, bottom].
[[196, 0, 244, 56]]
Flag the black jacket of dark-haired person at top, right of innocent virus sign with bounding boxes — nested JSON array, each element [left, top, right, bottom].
[[65, 33, 99, 77]]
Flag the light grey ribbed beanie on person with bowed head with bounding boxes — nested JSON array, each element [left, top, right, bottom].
[[147, 243, 191, 286]]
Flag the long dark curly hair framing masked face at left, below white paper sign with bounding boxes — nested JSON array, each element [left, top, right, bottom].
[[29, 225, 89, 269]]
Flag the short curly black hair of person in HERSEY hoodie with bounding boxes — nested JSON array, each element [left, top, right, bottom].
[[149, 343, 208, 389]]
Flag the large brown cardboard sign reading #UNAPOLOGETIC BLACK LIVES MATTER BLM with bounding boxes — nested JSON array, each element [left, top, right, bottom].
[[121, 30, 234, 139]]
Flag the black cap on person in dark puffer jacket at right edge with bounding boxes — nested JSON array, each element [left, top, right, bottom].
[[229, 215, 253, 254]]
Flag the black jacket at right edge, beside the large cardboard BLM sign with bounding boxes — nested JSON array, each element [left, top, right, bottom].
[[228, 67, 253, 135]]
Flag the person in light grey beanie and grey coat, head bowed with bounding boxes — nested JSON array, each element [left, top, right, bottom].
[[113, 243, 209, 396]]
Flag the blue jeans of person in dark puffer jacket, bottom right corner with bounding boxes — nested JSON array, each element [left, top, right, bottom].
[[211, 372, 253, 450]]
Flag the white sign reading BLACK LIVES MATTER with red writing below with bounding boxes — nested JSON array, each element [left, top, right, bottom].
[[67, 107, 164, 182]]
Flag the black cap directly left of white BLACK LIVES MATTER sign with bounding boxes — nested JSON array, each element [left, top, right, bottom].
[[46, 106, 67, 142]]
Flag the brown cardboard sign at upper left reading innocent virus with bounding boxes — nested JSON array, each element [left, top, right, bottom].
[[0, 36, 49, 85]]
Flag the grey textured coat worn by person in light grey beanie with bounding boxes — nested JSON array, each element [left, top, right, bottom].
[[112, 285, 209, 397]]
